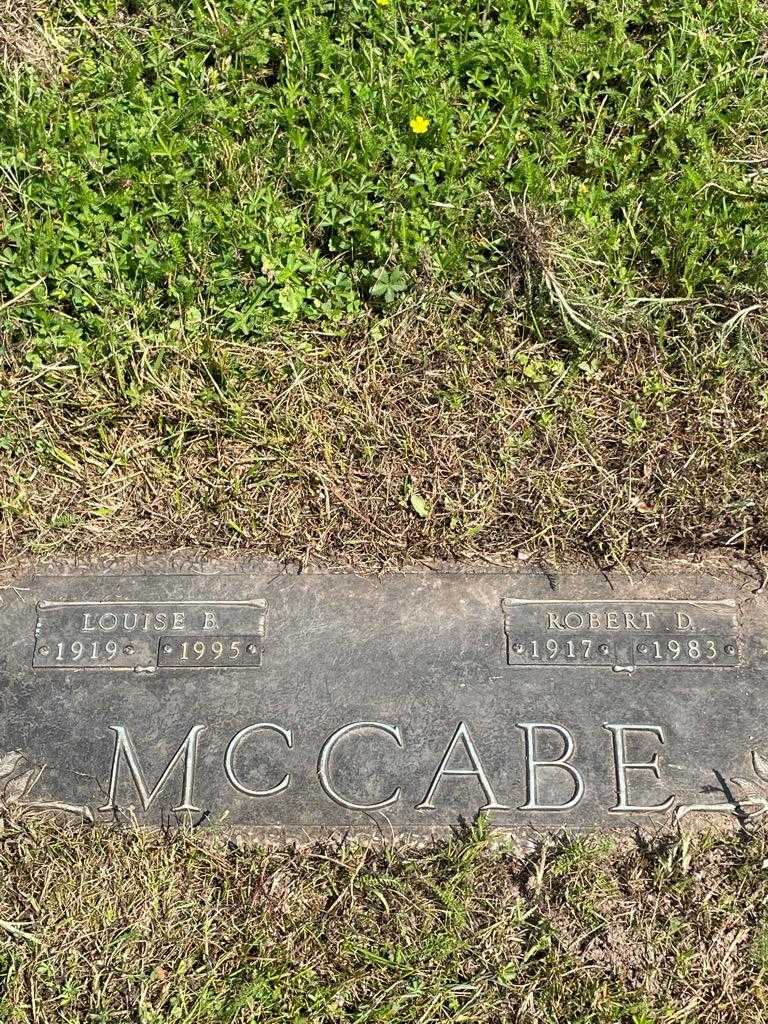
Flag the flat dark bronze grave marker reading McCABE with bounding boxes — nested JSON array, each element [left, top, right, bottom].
[[0, 562, 768, 837]]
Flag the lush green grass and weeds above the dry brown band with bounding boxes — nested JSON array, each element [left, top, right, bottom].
[[0, 0, 768, 337]]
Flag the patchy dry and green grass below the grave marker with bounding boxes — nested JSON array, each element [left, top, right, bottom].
[[0, 810, 768, 1024]]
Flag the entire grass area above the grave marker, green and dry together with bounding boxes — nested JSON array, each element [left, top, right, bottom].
[[0, 0, 768, 561]]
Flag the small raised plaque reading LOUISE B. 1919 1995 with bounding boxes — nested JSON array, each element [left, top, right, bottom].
[[33, 599, 266, 672]]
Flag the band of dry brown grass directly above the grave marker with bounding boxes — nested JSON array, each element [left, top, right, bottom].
[[0, 300, 768, 565]]
